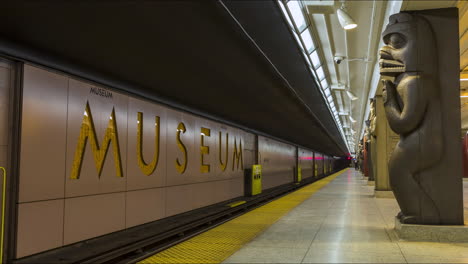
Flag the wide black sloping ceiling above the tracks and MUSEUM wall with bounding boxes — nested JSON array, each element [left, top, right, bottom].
[[0, 1, 345, 155]]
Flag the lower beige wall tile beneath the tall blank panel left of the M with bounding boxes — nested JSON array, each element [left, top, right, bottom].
[[16, 199, 64, 258]]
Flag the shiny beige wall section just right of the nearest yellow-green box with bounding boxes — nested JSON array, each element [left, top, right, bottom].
[[258, 136, 296, 189]]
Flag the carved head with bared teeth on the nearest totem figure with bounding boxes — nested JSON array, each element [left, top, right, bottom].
[[379, 13, 437, 77]]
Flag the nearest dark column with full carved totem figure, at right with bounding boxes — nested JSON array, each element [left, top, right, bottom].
[[380, 8, 463, 225]]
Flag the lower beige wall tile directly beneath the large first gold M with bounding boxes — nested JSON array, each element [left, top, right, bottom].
[[64, 193, 125, 245]]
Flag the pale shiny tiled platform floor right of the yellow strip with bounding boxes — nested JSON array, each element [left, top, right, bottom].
[[225, 169, 468, 263]]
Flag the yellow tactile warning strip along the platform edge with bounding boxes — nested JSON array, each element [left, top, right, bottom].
[[139, 169, 346, 264]]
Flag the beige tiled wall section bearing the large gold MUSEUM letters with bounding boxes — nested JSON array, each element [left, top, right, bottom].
[[16, 65, 254, 257]]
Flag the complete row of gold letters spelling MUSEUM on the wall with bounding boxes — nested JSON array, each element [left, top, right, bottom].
[[70, 102, 244, 179]]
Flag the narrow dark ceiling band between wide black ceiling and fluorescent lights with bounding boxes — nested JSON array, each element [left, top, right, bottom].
[[223, 0, 345, 154]]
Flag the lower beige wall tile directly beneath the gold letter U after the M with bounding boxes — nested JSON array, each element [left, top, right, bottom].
[[126, 188, 166, 228]]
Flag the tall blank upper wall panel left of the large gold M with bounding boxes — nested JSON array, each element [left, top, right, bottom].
[[19, 65, 68, 202]]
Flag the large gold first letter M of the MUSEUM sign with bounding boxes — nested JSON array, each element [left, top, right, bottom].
[[70, 102, 123, 179]]
